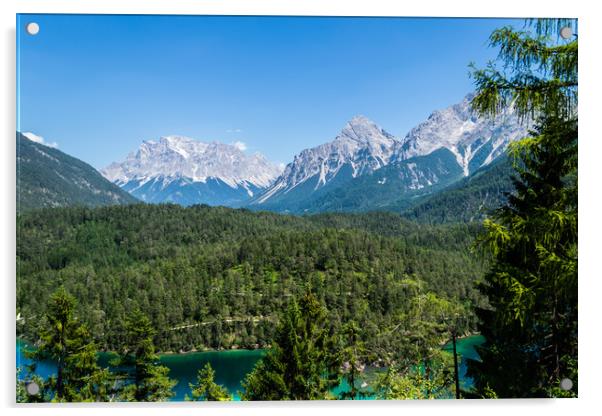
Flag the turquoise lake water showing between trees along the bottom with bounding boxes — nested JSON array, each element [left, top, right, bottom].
[[16, 335, 484, 401]]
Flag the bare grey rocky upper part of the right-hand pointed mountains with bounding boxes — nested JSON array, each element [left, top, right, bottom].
[[253, 93, 529, 211]]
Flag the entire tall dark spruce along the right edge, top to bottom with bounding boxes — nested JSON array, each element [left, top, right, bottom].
[[469, 19, 578, 397]]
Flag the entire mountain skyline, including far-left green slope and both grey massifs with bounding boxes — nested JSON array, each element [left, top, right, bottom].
[[17, 94, 529, 222]]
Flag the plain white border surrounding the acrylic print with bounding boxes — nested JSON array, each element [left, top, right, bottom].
[[0, 0, 602, 416]]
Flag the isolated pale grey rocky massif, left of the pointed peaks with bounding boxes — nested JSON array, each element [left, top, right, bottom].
[[101, 136, 281, 206]]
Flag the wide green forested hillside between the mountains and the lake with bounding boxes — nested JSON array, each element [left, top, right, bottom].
[[17, 205, 484, 351]]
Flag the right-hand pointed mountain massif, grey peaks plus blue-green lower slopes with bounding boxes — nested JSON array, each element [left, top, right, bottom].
[[250, 94, 528, 213]]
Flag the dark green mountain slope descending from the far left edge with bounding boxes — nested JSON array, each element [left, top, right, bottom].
[[16, 132, 139, 212]]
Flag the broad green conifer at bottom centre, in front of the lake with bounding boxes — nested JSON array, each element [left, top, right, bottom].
[[242, 293, 340, 400]]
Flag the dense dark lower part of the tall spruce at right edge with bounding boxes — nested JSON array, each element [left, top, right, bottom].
[[472, 114, 577, 397]]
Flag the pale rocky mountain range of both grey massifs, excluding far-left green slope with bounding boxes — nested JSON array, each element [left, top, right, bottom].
[[101, 94, 528, 213]]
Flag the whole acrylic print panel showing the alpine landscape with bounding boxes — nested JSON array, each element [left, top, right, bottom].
[[16, 14, 578, 402]]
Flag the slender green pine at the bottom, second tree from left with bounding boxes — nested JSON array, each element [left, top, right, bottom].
[[117, 310, 177, 402]]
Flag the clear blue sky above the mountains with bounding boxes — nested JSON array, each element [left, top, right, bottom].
[[17, 15, 523, 168]]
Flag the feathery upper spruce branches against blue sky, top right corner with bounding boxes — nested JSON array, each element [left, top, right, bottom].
[[472, 19, 578, 118]]
